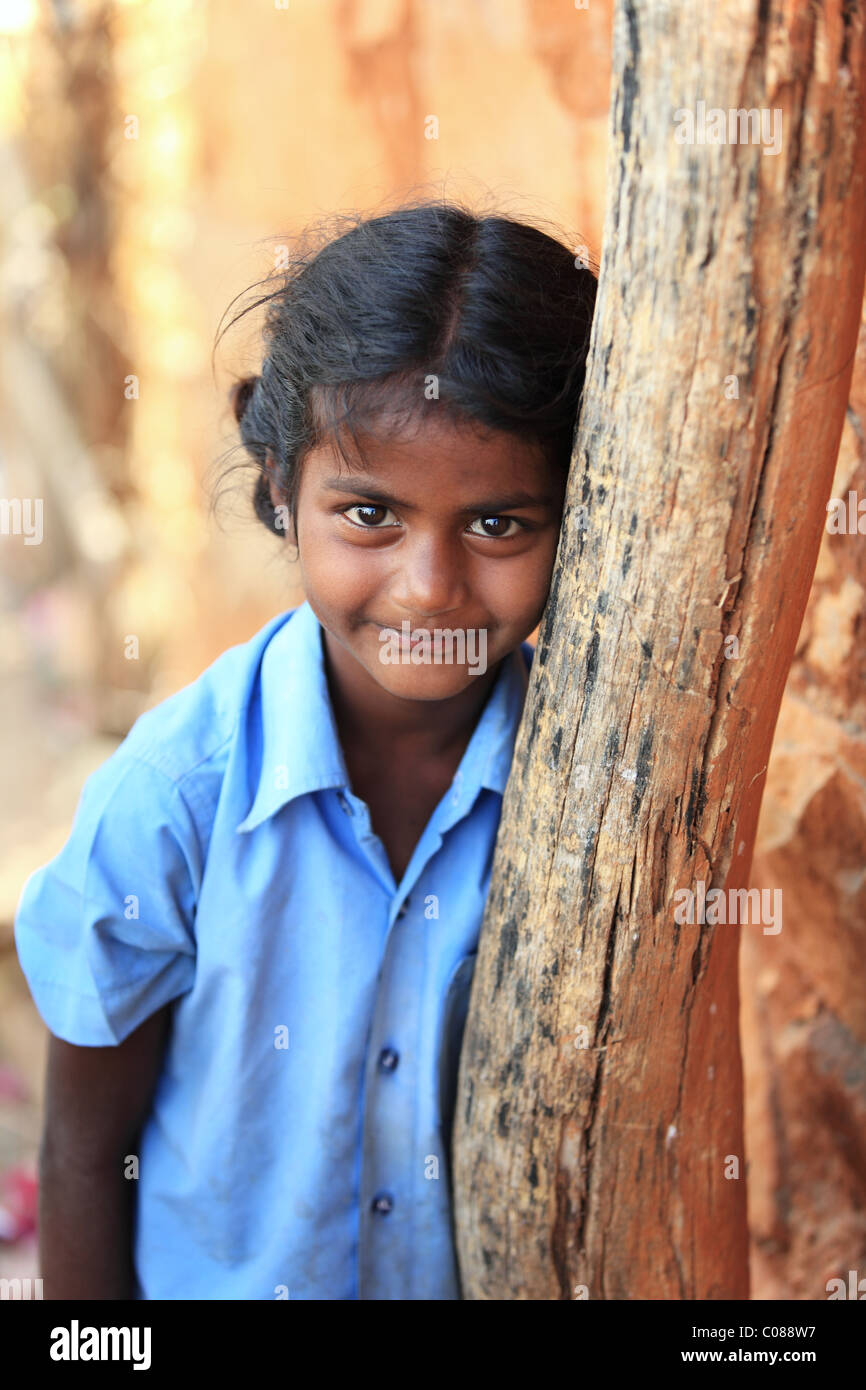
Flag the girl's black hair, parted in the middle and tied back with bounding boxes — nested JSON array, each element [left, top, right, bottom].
[[214, 199, 598, 537]]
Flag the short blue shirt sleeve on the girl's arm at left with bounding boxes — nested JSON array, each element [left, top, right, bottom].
[[15, 745, 202, 1047]]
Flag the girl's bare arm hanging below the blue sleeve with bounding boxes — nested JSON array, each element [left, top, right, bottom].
[[39, 1002, 171, 1298]]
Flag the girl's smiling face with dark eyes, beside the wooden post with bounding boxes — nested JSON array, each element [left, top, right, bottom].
[[271, 405, 566, 701]]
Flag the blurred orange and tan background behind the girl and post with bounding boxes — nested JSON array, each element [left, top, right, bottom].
[[0, 0, 866, 1298]]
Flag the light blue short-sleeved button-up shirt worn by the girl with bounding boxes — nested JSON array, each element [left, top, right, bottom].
[[15, 602, 532, 1300]]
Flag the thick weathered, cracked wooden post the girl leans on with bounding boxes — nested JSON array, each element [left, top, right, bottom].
[[455, 0, 866, 1300]]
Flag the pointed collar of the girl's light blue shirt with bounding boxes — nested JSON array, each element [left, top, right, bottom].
[[238, 600, 532, 831]]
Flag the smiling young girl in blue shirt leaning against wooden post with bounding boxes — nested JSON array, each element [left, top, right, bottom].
[[15, 203, 596, 1300]]
